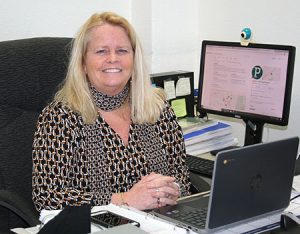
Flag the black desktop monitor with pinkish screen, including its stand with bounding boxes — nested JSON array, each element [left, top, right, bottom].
[[197, 40, 296, 145]]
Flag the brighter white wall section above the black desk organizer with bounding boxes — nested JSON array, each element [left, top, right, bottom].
[[152, 0, 200, 72]]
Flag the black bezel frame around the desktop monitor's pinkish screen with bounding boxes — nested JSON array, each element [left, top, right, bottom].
[[197, 40, 296, 126]]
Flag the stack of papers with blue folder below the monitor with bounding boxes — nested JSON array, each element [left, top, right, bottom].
[[179, 118, 238, 155]]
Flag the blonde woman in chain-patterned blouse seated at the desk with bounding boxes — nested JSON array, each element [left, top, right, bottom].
[[33, 12, 190, 211]]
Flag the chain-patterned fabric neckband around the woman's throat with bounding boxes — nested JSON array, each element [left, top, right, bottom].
[[90, 84, 129, 111]]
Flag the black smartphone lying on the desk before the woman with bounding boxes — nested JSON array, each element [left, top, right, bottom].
[[91, 210, 140, 228]]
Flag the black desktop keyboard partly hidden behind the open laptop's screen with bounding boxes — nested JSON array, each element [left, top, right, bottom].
[[186, 154, 215, 177]]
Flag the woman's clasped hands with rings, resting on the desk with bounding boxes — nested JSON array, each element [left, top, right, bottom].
[[120, 173, 179, 210]]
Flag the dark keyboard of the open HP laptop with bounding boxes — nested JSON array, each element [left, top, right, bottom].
[[173, 208, 207, 228]]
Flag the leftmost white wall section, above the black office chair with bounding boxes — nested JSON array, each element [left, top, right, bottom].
[[0, 0, 131, 41]]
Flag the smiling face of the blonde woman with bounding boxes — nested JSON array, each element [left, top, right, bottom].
[[83, 24, 134, 95]]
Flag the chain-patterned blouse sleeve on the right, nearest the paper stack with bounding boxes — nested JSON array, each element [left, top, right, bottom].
[[159, 103, 190, 196]]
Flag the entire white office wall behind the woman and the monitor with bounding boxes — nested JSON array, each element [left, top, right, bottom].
[[0, 0, 300, 144]]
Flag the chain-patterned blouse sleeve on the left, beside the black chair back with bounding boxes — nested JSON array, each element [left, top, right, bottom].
[[32, 105, 91, 211]]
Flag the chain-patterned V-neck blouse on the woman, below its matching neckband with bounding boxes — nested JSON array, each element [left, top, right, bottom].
[[32, 103, 190, 211]]
